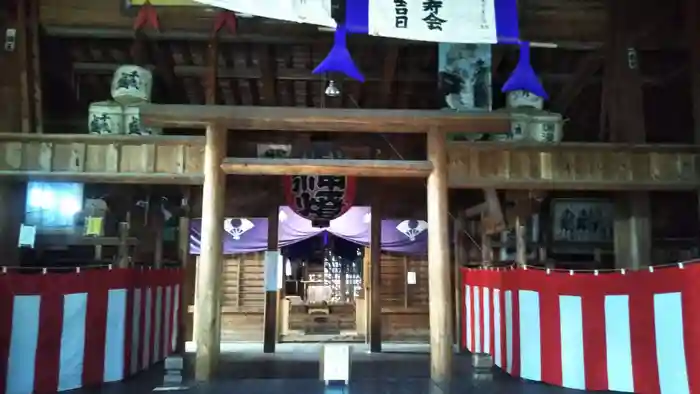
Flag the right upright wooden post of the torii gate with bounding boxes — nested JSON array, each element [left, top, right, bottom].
[[427, 130, 454, 386]]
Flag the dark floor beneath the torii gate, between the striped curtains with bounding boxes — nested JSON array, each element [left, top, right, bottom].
[[74, 343, 616, 394]]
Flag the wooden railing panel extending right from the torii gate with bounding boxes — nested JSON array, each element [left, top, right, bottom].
[[447, 142, 700, 190]]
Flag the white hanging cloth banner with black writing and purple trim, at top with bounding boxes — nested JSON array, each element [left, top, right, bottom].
[[195, 0, 518, 43]]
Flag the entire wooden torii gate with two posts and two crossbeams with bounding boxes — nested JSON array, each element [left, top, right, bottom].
[[141, 104, 509, 382]]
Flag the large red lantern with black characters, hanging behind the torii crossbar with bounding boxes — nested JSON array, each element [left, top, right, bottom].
[[283, 143, 356, 228]]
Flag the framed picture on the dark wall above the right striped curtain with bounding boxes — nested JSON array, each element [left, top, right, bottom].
[[551, 198, 615, 243]]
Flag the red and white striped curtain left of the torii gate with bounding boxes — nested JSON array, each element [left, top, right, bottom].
[[0, 269, 183, 394]]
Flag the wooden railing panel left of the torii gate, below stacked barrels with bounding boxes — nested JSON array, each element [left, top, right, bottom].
[[0, 133, 204, 184]]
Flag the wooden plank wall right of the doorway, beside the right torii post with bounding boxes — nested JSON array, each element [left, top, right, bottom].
[[379, 253, 430, 341]]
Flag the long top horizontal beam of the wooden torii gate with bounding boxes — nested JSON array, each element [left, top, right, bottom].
[[141, 104, 510, 133]]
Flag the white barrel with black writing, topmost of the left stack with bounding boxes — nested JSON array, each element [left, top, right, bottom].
[[112, 65, 153, 105]]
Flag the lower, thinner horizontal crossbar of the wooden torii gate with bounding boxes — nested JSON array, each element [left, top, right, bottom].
[[221, 157, 433, 178]]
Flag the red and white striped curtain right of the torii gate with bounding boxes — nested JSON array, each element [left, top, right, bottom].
[[462, 262, 700, 394]]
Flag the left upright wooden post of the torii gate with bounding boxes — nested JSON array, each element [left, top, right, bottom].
[[194, 125, 226, 381]]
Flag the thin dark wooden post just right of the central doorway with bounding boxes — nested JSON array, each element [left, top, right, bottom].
[[369, 197, 382, 353]]
